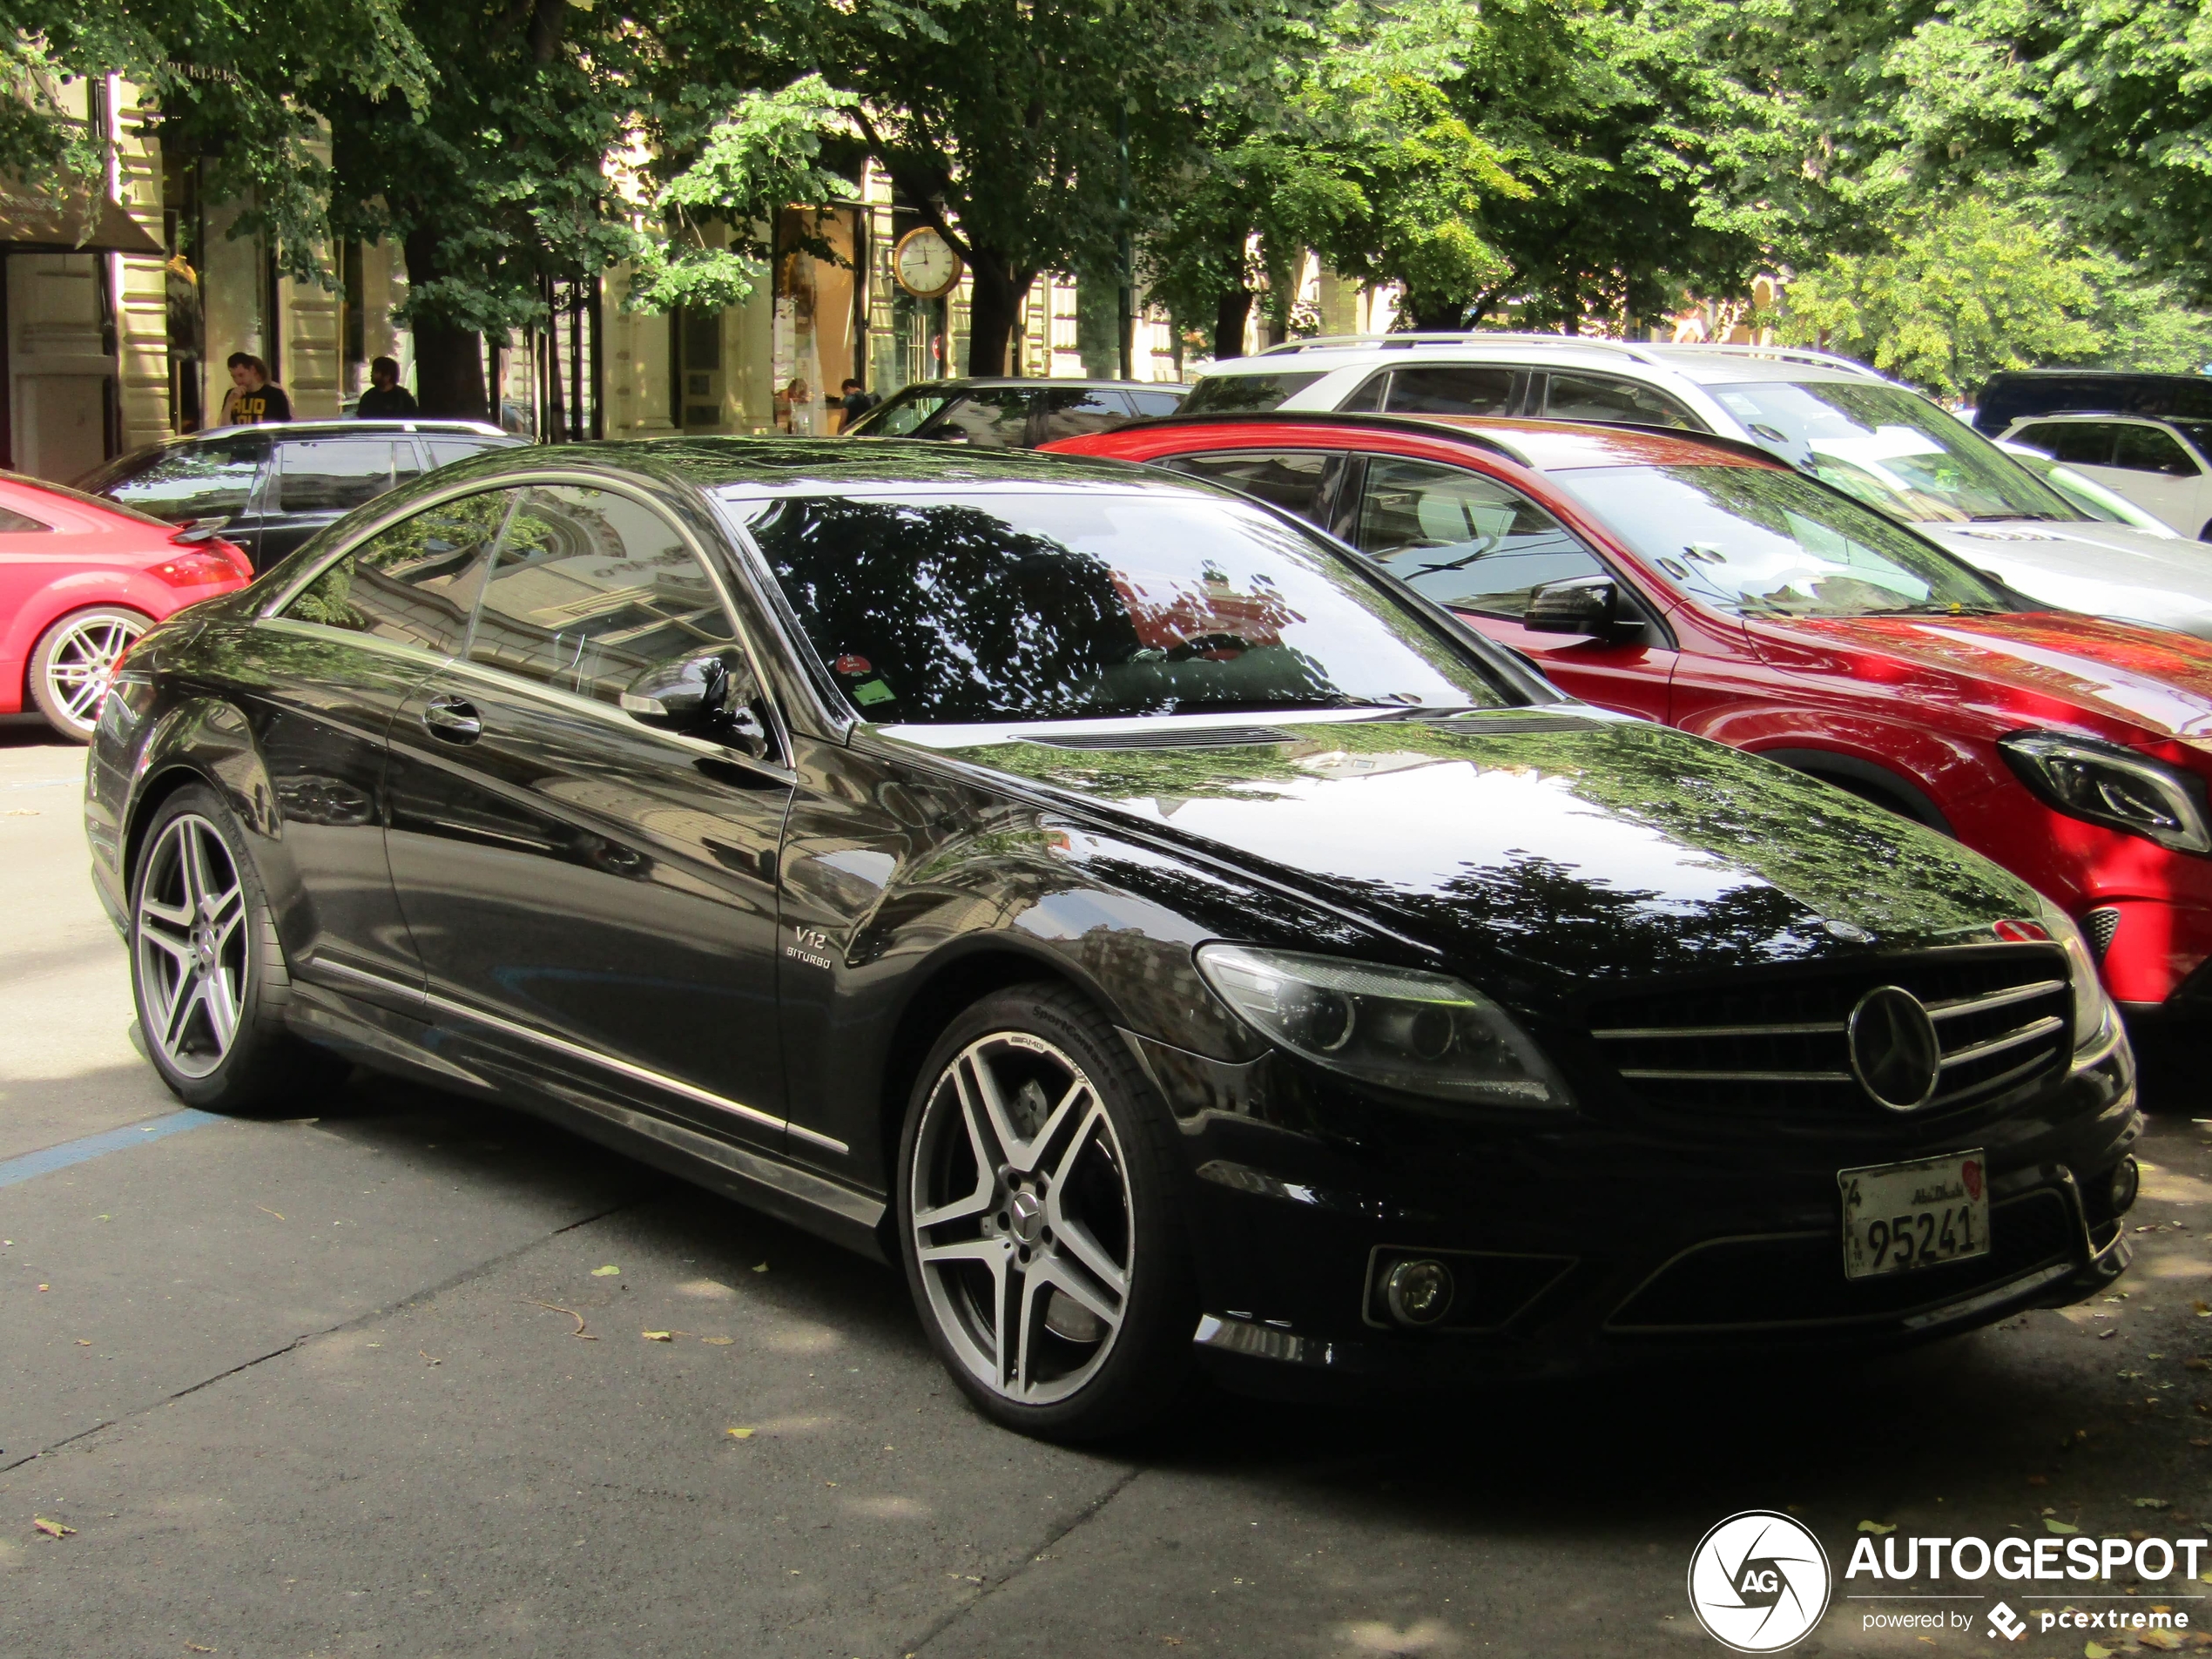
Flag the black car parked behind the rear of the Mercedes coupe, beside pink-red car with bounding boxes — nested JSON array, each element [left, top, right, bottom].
[[78, 421, 522, 570]]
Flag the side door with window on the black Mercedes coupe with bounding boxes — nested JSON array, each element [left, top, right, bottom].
[[389, 487, 790, 1142]]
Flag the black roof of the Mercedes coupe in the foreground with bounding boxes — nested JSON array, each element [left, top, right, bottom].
[[460, 438, 1188, 496]]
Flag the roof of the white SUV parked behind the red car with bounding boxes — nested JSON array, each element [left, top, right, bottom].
[[1205, 329, 1892, 385]]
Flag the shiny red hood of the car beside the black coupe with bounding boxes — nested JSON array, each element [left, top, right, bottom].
[[1745, 610, 2212, 743]]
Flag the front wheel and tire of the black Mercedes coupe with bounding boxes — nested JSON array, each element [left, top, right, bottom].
[[896, 984, 1199, 1440]]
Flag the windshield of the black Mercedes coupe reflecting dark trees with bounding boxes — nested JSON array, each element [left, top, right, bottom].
[[743, 484, 1508, 725]]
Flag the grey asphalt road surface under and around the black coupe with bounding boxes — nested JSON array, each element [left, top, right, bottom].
[[0, 730, 2212, 1659]]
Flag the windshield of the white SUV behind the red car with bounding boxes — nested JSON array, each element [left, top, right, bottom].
[[1712, 381, 2081, 524]]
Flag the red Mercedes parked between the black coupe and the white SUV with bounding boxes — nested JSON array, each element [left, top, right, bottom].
[[1046, 414, 2212, 1020]]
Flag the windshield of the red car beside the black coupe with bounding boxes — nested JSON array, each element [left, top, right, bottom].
[[1551, 464, 2013, 617]]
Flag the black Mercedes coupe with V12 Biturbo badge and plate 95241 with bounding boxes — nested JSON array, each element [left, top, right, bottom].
[[86, 440, 2139, 1438]]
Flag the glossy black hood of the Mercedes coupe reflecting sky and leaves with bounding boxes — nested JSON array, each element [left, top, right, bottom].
[[907, 705, 2040, 995]]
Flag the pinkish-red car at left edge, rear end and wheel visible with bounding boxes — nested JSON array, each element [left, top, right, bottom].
[[0, 474, 254, 743]]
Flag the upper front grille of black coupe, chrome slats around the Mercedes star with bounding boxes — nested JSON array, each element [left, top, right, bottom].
[[1590, 945, 2073, 1126]]
